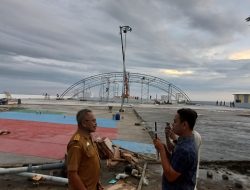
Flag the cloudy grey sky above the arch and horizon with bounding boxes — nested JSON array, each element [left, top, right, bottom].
[[0, 0, 250, 101]]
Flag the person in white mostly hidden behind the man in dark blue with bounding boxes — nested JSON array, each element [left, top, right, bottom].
[[165, 124, 202, 190]]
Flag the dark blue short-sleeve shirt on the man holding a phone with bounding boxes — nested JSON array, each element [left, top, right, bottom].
[[162, 137, 198, 190]]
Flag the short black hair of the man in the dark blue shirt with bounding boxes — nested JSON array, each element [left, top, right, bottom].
[[177, 108, 198, 130]]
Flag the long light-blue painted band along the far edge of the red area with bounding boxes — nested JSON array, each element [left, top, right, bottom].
[[0, 112, 116, 128]]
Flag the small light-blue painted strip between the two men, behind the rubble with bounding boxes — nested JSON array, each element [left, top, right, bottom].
[[112, 140, 156, 154]]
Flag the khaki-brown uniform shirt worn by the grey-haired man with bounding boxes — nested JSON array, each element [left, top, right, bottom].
[[67, 129, 100, 190]]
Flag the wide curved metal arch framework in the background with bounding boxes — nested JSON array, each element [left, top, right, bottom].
[[59, 72, 190, 103]]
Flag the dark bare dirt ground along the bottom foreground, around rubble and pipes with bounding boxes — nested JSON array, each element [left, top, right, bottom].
[[0, 161, 250, 190]]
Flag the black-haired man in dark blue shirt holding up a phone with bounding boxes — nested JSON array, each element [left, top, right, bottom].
[[153, 108, 198, 190]]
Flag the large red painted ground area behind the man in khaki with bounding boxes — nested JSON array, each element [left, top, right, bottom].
[[0, 119, 117, 159]]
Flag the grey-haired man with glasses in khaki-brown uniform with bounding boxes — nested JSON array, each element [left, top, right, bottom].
[[67, 109, 103, 190]]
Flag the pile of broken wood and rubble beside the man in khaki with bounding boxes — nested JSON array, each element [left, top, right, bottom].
[[96, 138, 157, 190]]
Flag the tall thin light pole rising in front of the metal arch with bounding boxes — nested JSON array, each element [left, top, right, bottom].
[[120, 26, 132, 112]]
